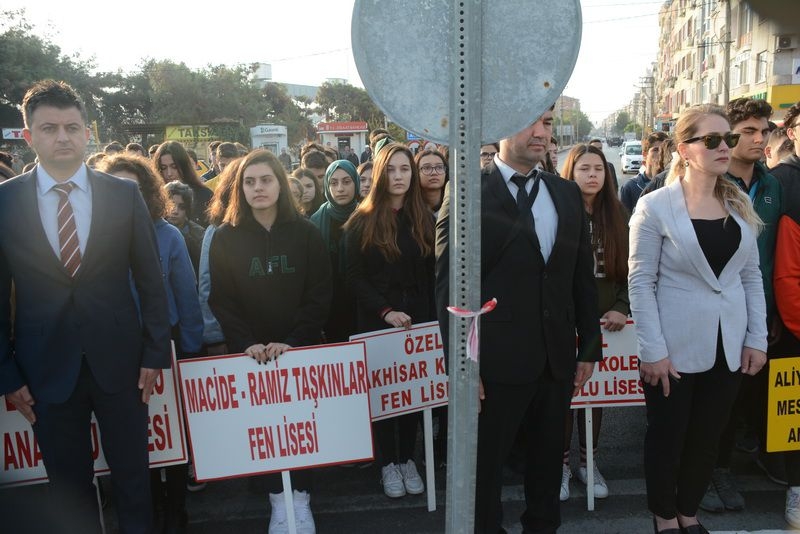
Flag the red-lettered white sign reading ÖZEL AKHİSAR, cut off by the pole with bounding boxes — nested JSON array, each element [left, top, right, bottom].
[[350, 321, 449, 421]]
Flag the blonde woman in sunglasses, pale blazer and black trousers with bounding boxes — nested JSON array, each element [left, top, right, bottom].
[[628, 105, 767, 534]]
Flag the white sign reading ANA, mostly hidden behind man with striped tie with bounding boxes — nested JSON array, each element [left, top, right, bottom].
[[0, 360, 188, 488]]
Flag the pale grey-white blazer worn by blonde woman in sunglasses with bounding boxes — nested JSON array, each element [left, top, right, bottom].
[[628, 180, 767, 373]]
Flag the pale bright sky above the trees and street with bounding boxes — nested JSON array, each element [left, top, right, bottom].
[[2, 0, 663, 122]]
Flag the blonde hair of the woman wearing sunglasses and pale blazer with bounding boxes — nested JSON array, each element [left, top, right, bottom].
[[666, 104, 764, 232]]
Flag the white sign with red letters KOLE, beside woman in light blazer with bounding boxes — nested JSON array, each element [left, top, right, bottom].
[[572, 319, 644, 408]]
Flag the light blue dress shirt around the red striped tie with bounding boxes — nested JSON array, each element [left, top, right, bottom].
[[36, 165, 92, 261]]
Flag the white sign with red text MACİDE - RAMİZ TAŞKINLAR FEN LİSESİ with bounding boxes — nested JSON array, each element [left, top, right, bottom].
[[178, 343, 373, 486]]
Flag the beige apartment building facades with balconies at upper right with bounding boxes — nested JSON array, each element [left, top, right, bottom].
[[647, 0, 800, 131]]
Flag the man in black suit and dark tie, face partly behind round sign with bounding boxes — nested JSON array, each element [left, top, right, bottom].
[[436, 109, 601, 534]]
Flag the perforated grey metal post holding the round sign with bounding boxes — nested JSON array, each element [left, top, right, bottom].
[[445, 0, 488, 534]]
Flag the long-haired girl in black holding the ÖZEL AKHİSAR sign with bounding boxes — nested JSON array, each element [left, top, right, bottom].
[[345, 143, 435, 498]]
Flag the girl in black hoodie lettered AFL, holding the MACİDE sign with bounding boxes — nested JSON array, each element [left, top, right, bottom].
[[208, 150, 331, 532]]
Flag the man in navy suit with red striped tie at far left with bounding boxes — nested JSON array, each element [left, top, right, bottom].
[[0, 80, 170, 534]]
